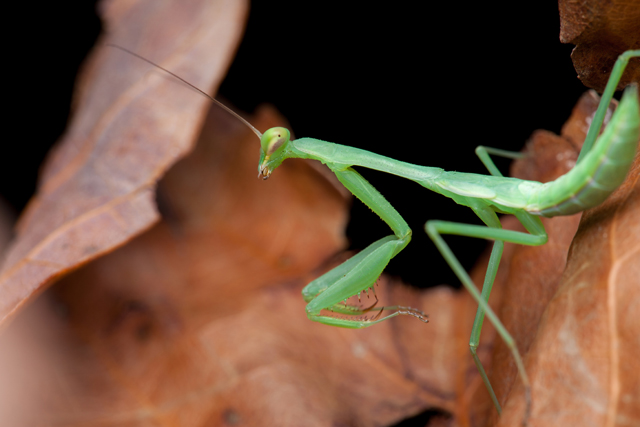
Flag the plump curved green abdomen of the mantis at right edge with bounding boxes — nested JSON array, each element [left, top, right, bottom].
[[526, 86, 640, 217]]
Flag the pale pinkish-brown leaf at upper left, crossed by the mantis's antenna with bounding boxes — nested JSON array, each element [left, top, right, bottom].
[[0, 0, 247, 330]]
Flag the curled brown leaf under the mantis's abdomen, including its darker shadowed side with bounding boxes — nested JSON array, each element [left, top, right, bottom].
[[476, 92, 640, 426]]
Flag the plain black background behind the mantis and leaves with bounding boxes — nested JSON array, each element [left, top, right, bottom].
[[7, 1, 586, 287]]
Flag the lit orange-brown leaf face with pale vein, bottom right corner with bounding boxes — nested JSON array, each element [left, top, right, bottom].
[[501, 156, 640, 426]]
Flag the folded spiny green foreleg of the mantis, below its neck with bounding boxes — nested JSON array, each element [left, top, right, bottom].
[[303, 165, 426, 328]]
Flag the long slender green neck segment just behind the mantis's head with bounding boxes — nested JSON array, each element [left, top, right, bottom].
[[290, 138, 444, 188]]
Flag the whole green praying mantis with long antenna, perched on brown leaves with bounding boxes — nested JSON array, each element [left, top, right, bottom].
[[111, 45, 640, 423]]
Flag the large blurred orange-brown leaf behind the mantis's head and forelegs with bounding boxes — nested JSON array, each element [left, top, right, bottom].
[[0, 96, 466, 426]]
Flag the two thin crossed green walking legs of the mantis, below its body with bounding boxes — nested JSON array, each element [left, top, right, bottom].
[[425, 203, 547, 422]]
